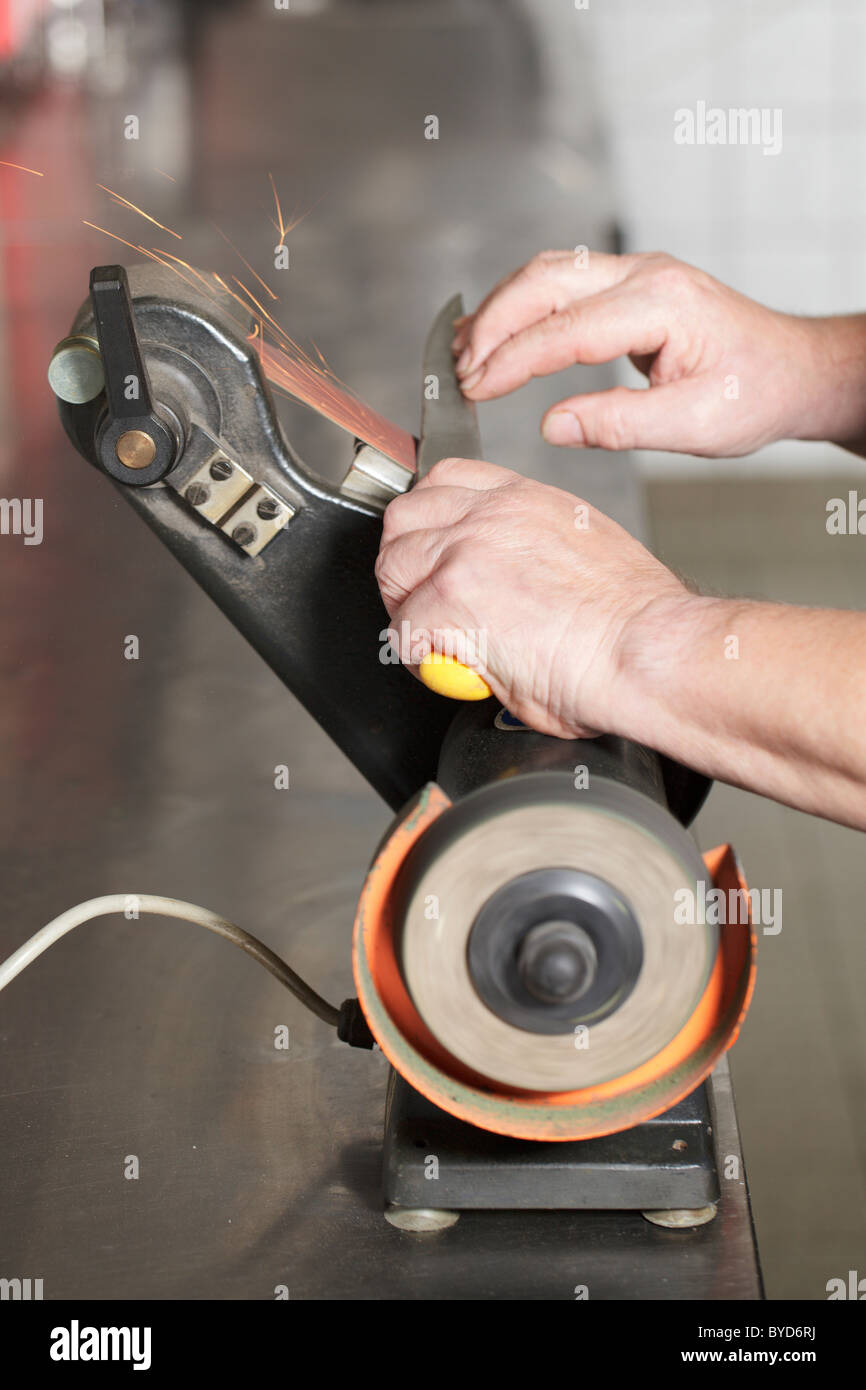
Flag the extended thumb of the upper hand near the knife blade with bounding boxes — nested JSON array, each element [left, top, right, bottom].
[[541, 377, 723, 453]]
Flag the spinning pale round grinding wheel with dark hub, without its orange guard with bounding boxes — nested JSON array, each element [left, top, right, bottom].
[[398, 776, 717, 1091]]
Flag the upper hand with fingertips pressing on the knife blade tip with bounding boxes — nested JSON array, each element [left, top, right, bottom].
[[455, 252, 866, 457]]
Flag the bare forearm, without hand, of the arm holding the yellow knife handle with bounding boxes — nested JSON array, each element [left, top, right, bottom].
[[614, 595, 866, 828]]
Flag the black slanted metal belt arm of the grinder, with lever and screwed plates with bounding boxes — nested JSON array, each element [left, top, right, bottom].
[[49, 264, 455, 810]]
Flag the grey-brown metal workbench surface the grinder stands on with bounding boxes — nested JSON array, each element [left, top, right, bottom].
[[0, 3, 758, 1300]]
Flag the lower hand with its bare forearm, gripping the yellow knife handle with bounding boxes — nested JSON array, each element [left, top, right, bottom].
[[377, 459, 866, 830]]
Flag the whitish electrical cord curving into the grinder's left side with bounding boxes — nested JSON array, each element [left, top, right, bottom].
[[0, 892, 341, 1027]]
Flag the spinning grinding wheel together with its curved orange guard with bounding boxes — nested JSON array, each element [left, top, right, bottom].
[[356, 771, 751, 1140]]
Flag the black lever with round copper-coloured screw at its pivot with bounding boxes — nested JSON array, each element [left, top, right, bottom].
[[90, 265, 178, 487]]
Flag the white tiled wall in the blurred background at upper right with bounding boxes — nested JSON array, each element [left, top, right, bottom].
[[525, 0, 866, 473]]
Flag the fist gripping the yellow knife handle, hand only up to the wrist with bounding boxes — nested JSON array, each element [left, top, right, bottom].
[[377, 459, 684, 738]]
